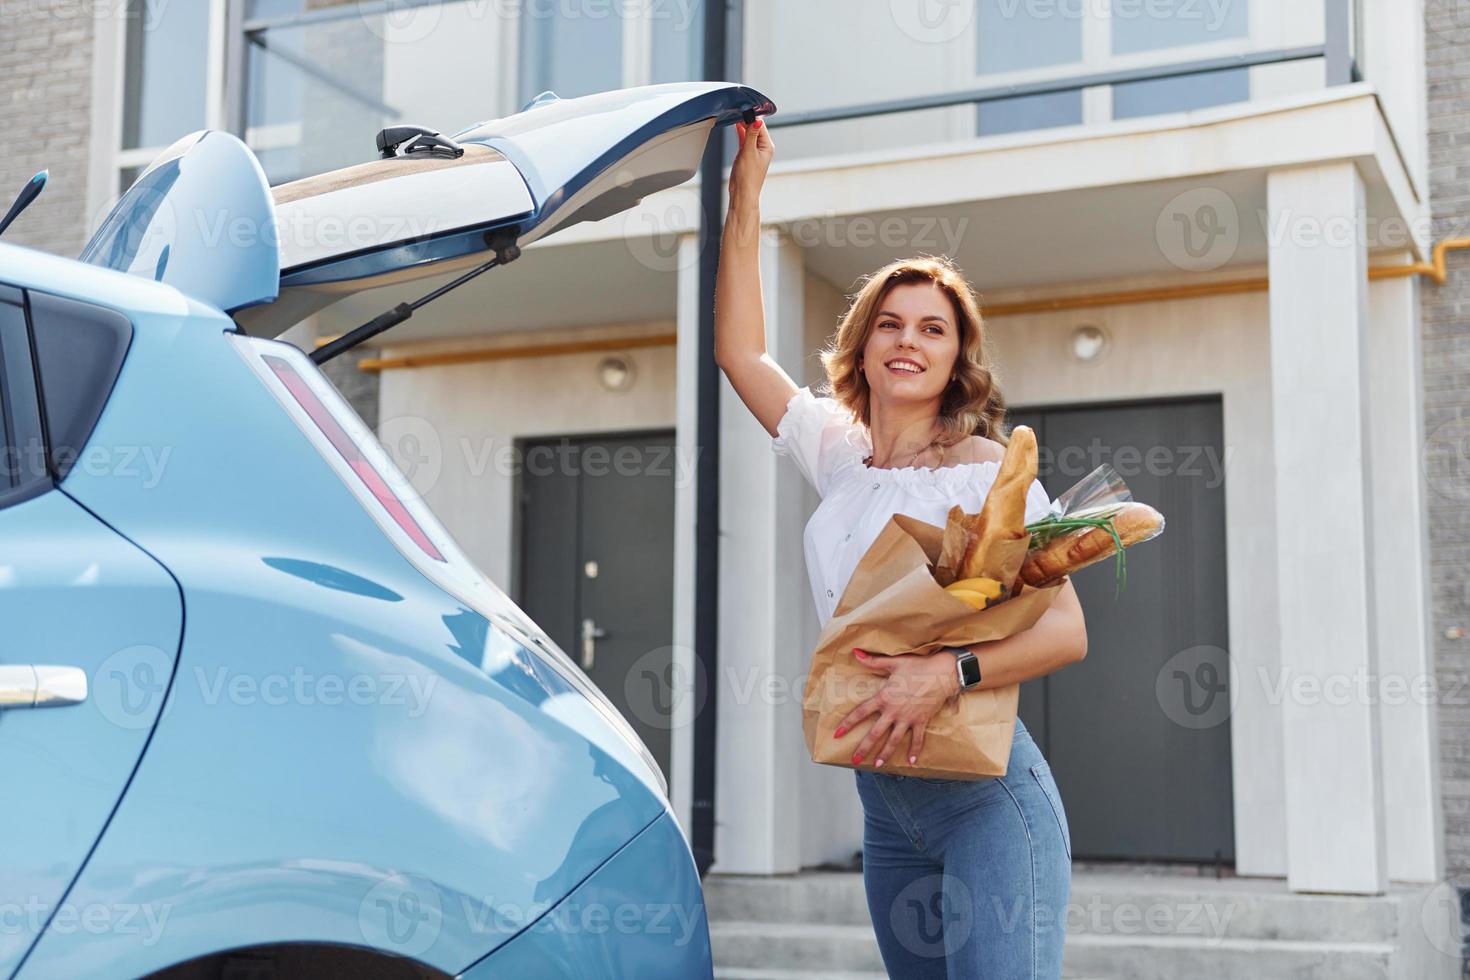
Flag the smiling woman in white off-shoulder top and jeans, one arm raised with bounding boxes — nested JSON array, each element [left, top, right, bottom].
[[714, 119, 1086, 980]]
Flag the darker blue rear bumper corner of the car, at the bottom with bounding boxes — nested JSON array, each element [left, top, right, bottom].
[[460, 815, 710, 980]]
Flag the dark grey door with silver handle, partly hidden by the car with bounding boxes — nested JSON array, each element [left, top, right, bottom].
[[516, 432, 675, 776]]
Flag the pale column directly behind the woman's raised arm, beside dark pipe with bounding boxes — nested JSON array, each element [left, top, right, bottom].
[[714, 229, 811, 874]]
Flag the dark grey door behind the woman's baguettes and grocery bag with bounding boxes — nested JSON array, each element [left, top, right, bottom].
[[1010, 398, 1235, 864]]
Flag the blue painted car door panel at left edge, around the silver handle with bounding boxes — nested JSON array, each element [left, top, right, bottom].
[[0, 499, 184, 976]]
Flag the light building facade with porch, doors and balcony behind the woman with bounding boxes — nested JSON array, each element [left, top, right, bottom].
[[0, 0, 1470, 976]]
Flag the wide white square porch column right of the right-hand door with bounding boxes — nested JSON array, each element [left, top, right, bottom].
[[1264, 163, 1387, 893]]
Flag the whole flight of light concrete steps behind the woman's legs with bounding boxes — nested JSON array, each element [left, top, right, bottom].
[[704, 871, 1458, 980]]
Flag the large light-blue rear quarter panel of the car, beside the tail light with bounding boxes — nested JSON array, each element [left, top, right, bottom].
[[0, 253, 686, 977]]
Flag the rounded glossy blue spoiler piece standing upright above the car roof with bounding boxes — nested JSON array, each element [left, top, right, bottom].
[[81, 131, 281, 313]]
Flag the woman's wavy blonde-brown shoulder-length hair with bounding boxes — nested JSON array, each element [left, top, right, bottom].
[[820, 256, 1010, 445]]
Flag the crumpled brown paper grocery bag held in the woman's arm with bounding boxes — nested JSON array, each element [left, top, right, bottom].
[[801, 514, 1067, 779]]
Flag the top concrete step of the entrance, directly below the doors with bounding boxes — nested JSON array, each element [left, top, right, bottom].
[[704, 873, 1402, 942]]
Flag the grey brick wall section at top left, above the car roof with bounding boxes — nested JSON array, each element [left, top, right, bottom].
[[0, 0, 96, 257]]
